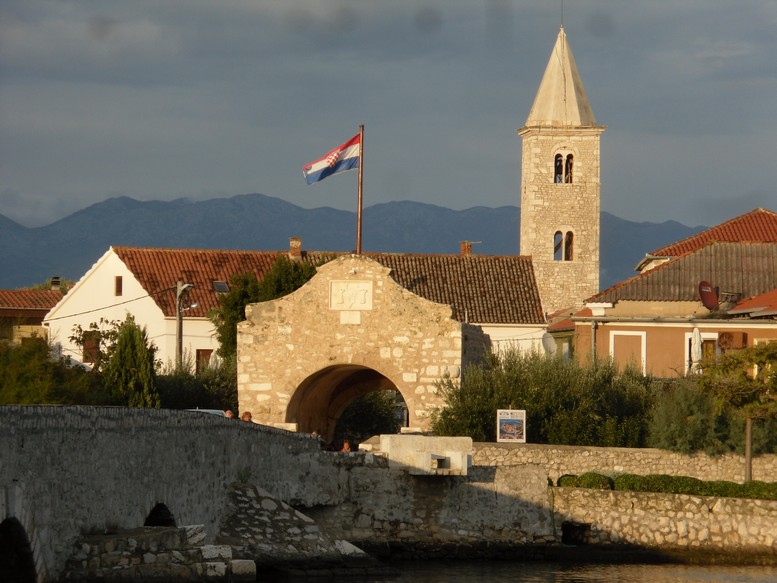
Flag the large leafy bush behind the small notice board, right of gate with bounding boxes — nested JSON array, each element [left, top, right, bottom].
[[432, 350, 652, 447]]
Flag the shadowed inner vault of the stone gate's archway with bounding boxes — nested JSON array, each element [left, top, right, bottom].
[[286, 364, 408, 441]]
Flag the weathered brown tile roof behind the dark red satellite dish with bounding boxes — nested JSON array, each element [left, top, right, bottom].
[[586, 243, 777, 302]]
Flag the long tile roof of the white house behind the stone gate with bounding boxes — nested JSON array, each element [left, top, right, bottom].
[[113, 247, 544, 324]]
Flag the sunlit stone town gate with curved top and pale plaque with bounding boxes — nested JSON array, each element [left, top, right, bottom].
[[237, 255, 463, 437]]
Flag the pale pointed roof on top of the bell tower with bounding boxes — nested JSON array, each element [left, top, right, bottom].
[[526, 26, 597, 127]]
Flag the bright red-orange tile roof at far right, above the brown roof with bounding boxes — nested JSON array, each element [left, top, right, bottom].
[[650, 208, 777, 257]]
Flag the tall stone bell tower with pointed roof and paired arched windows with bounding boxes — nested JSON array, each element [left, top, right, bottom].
[[518, 26, 605, 313]]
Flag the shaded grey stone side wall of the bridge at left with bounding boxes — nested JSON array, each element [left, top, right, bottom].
[[0, 406, 345, 580]]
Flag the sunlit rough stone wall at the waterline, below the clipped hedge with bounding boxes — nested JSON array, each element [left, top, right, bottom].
[[552, 488, 777, 555]]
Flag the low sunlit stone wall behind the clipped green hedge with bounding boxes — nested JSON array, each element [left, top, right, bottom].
[[473, 443, 777, 483]]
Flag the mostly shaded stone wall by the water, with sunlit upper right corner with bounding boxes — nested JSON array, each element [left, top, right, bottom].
[[305, 460, 554, 549]]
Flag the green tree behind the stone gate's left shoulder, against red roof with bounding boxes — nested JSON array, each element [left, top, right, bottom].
[[210, 255, 316, 359]]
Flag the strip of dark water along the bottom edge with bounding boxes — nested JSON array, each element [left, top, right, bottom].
[[350, 561, 777, 583]]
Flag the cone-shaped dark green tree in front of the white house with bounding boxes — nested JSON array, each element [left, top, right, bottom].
[[105, 314, 160, 409]]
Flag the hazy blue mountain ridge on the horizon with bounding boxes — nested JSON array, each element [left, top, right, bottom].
[[0, 194, 704, 289]]
